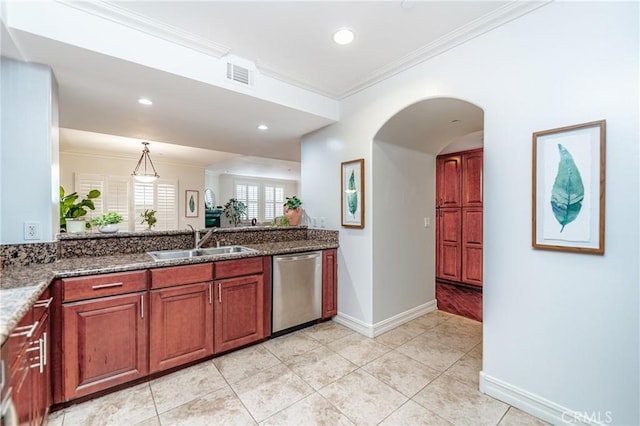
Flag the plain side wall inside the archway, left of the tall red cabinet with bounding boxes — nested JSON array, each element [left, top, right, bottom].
[[371, 141, 435, 322]]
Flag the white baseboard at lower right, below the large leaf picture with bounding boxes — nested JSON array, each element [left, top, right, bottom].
[[480, 371, 612, 426]]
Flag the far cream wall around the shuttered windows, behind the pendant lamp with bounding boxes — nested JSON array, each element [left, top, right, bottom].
[[60, 151, 205, 229]]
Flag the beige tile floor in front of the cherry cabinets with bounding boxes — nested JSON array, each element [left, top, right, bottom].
[[48, 311, 546, 426]]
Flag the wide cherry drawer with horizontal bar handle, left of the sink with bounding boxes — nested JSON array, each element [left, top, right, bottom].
[[62, 271, 147, 302]]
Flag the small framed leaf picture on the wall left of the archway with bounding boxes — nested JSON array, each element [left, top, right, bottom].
[[340, 158, 364, 229]]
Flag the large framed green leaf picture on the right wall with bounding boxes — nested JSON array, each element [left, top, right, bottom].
[[531, 120, 606, 254]]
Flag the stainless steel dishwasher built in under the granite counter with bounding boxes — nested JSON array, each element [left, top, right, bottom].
[[271, 251, 322, 333]]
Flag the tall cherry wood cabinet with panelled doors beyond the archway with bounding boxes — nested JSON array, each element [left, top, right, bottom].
[[436, 149, 482, 287]]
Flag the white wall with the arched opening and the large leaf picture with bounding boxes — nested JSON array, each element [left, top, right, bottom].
[[301, 2, 640, 425]]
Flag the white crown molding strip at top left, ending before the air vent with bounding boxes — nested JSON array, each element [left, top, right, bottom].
[[56, 0, 231, 58]]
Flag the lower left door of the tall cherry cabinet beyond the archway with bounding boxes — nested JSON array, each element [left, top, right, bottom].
[[436, 208, 462, 281]]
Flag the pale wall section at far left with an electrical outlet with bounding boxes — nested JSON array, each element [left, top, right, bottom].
[[0, 57, 59, 244]]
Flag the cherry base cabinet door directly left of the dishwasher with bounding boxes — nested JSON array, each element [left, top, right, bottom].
[[214, 275, 265, 353]]
